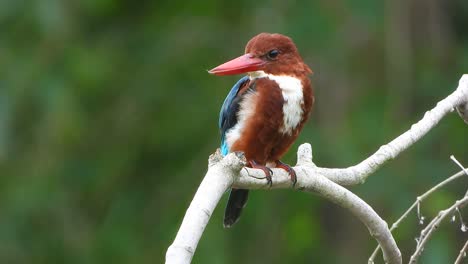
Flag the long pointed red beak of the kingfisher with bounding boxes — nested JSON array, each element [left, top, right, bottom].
[[208, 53, 265, 75]]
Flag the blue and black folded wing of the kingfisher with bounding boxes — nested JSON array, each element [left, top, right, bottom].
[[218, 76, 249, 156]]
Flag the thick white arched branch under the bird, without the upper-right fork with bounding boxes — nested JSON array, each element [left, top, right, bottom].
[[166, 144, 401, 263]]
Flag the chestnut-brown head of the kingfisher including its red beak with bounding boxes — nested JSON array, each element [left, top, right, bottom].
[[209, 33, 312, 76]]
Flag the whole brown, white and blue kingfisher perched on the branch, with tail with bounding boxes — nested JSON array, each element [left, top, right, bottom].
[[208, 33, 314, 228]]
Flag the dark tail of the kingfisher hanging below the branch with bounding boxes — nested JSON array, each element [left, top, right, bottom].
[[224, 189, 249, 228]]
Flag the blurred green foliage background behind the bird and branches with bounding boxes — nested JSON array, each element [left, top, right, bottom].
[[0, 0, 468, 263]]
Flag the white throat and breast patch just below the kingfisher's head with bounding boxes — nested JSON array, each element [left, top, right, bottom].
[[250, 71, 304, 134]]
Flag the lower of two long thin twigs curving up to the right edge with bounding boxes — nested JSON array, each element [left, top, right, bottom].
[[409, 196, 468, 264]]
